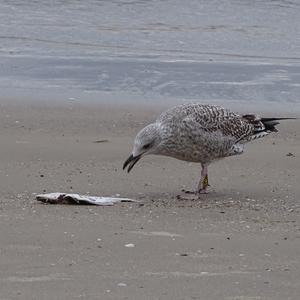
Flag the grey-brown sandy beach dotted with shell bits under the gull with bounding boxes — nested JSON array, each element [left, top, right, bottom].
[[0, 101, 300, 300]]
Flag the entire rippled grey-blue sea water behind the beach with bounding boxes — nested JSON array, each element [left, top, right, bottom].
[[0, 0, 300, 110]]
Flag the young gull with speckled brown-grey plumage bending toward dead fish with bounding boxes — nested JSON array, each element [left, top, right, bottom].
[[123, 103, 291, 193]]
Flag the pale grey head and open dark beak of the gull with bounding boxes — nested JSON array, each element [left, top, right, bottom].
[[123, 123, 162, 172]]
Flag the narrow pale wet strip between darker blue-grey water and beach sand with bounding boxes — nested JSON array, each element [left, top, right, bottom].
[[0, 89, 300, 117]]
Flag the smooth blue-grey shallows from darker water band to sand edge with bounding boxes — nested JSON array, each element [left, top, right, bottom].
[[0, 56, 300, 113]]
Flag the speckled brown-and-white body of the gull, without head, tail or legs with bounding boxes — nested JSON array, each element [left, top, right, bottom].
[[156, 104, 263, 164]]
